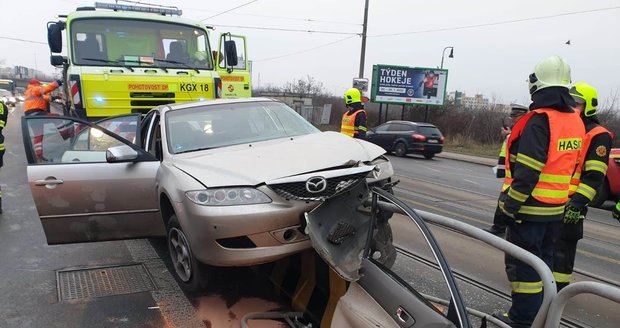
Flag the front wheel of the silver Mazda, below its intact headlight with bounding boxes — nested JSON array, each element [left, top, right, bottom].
[[166, 214, 207, 293]]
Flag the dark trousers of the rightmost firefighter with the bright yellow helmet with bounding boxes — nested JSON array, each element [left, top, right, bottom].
[[553, 220, 583, 292]]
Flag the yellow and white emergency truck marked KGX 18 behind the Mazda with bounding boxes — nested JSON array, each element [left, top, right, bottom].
[[47, 2, 251, 120]]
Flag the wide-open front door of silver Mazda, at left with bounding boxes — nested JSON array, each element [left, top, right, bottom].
[[22, 114, 165, 245]]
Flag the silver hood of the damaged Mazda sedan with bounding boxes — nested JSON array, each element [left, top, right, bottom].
[[172, 132, 385, 188]]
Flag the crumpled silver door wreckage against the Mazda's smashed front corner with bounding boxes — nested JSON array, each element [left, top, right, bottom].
[[306, 184, 471, 328]]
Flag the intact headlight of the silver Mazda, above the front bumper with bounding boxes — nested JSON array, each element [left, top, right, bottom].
[[185, 187, 271, 206]]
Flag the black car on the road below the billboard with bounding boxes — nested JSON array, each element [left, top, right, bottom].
[[366, 121, 444, 159]]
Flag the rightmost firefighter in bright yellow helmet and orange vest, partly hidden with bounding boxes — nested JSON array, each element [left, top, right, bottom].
[[553, 82, 613, 291]]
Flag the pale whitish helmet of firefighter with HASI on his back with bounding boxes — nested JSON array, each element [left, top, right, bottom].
[[527, 56, 570, 94]]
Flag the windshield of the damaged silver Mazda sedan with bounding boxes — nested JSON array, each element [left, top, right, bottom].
[[165, 101, 320, 154]]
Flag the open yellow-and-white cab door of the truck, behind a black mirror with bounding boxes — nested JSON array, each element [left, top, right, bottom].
[[214, 33, 252, 98]]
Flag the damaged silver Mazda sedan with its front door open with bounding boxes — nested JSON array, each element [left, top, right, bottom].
[[22, 98, 393, 290]]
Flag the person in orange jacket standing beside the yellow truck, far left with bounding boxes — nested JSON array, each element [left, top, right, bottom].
[[24, 79, 62, 160]]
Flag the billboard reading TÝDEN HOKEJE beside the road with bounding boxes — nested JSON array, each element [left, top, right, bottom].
[[370, 65, 448, 106]]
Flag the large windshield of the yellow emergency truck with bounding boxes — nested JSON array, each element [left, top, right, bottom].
[[70, 18, 213, 70]]
